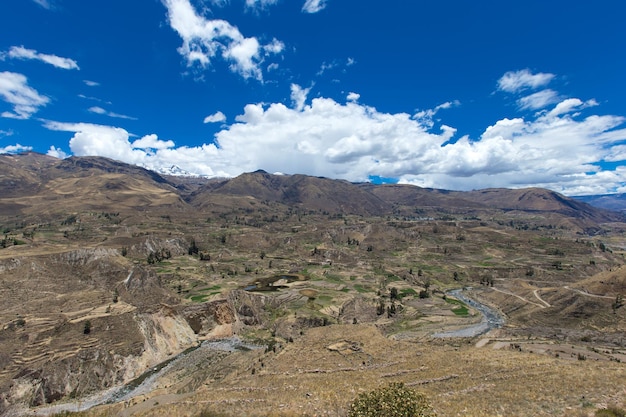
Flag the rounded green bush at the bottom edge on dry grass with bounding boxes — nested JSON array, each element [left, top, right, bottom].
[[348, 383, 436, 417]]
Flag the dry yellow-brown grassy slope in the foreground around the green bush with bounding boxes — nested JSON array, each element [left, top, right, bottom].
[[89, 325, 626, 417]]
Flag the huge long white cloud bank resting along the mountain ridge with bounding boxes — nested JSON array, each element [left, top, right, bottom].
[[46, 84, 626, 195]]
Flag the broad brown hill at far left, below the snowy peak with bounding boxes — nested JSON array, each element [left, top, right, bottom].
[[0, 153, 184, 216]]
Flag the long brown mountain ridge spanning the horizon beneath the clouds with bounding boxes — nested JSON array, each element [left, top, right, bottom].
[[0, 152, 624, 228]]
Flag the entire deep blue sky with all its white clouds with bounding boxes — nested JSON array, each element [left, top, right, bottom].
[[0, 0, 626, 195]]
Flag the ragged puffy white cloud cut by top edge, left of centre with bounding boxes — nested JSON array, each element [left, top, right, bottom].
[[163, 0, 284, 81]]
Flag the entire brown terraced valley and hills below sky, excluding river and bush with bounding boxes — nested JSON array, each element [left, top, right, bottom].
[[0, 153, 626, 416]]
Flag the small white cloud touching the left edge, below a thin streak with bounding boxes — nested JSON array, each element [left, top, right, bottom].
[[0, 71, 50, 119]]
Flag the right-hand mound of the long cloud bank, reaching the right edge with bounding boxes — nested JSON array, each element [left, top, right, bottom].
[[400, 99, 626, 195]]
